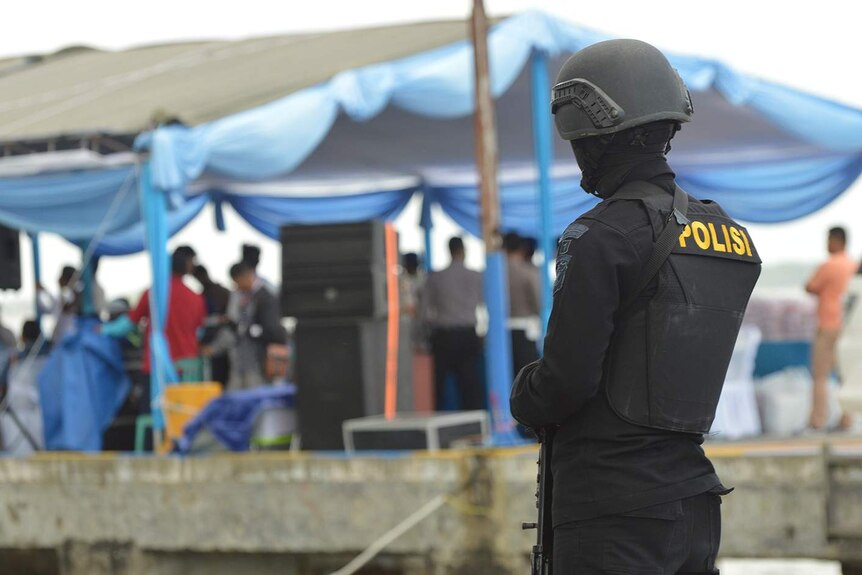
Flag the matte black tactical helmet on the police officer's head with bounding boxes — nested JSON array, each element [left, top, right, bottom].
[[551, 40, 694, 140]]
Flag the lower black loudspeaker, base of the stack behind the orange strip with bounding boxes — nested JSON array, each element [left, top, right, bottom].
[[294, 318, 413, 450]]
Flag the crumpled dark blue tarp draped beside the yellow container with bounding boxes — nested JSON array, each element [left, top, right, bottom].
[[177, 384, 296, 453]]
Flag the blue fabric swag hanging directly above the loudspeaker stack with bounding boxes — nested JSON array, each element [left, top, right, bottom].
[[224, 188, 414, 239]]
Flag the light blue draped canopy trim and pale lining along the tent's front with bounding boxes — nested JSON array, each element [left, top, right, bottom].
[[142, 12, 862, 235]]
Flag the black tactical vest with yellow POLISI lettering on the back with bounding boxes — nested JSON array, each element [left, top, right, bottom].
[[603, 182, 760, 433]]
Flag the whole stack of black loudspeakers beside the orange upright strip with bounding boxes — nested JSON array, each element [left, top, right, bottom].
[[281, 221, 413, 450]]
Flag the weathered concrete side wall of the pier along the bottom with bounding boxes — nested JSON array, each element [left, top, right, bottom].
[[0, 439, 862, 575]]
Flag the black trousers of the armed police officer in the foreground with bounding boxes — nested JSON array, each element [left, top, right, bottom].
[[554, 493, 721, 575]]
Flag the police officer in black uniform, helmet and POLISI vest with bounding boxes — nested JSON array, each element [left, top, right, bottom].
[[511, 40, 760, 575]]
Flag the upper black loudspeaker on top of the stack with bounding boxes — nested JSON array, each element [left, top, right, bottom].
[[281, 221, 386, 318]]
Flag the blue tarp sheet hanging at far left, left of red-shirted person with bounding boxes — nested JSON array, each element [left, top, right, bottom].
[[38, 319, 131, 451]]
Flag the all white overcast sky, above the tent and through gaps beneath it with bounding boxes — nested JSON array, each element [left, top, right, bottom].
[[0, 0, 862, 324]]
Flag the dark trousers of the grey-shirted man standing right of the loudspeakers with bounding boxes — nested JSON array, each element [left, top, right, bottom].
[[431, 327, 485, 410]]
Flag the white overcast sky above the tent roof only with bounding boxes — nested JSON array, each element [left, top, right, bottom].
[[0, 0, 862, 106]]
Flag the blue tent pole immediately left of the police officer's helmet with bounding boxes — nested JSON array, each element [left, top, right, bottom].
[[530, 50, 554, 333]]
